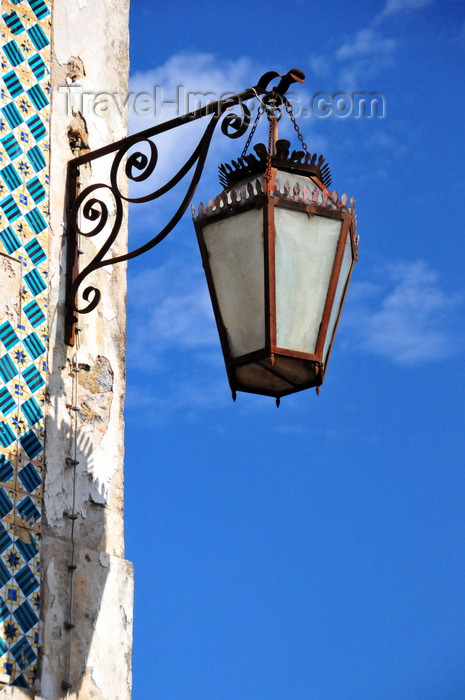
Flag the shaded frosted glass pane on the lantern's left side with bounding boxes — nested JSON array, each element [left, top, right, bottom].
[[203, 209, 265, 357]]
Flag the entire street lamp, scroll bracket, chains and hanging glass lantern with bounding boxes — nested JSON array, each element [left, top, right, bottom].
[[66, 69, 358, 405]]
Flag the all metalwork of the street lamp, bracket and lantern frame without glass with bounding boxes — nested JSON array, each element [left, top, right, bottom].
[[65, 68, 358, 405]]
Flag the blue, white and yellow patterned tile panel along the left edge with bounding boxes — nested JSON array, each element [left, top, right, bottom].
[[0, 0, 51, 688]]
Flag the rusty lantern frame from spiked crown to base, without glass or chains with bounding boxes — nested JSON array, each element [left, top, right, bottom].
[[193, 154, 358, 406]]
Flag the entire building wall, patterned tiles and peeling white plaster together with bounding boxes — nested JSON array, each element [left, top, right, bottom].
[[0, 0, 132, 700]]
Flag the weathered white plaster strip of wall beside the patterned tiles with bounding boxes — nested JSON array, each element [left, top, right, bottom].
[[30, 0, 133, 700]]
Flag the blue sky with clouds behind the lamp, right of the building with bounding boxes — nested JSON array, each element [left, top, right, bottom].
[[125, 0, 465, 700]]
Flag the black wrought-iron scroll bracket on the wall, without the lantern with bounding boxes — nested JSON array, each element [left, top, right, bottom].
[[65, 68, 305, 345]]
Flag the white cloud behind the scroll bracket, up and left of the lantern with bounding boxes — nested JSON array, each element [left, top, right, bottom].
[[122, 53, 280, 241]]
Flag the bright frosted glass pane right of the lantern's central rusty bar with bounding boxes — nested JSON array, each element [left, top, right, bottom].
[[275, 207, 342, 353]]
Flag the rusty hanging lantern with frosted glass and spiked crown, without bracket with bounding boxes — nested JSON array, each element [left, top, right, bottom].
[[190, 139, 358, 405]]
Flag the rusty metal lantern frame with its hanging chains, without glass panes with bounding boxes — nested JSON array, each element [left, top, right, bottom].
[[192, 115, 358, 405]]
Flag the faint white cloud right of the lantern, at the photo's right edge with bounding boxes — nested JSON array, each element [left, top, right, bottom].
[[343, 260, 463, 364]]
